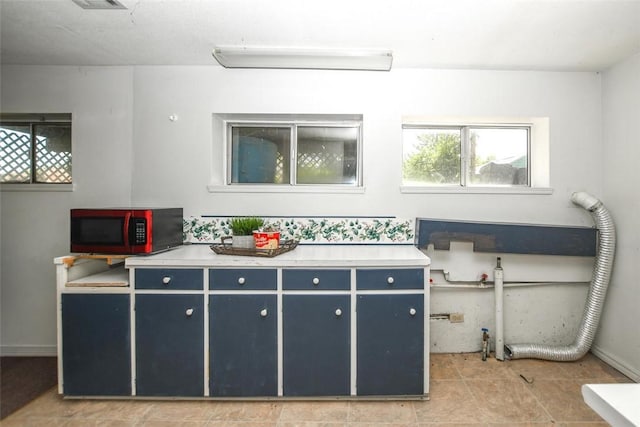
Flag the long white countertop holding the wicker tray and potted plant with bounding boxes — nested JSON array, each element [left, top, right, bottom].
[[125, 245, 431, 267]]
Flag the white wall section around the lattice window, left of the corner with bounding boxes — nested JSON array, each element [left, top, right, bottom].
[[0, 67, 133, 355]]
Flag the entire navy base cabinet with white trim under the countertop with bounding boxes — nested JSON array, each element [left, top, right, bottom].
[[58, 257, 429, 399]]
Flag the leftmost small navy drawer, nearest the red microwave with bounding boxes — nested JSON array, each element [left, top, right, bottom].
[[135, 268, 203, 290]]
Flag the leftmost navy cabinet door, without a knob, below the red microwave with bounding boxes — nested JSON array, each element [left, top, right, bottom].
[[62, 294, 131, 396]]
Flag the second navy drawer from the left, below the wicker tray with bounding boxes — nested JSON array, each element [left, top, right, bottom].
[[209, 268, 278, 291]]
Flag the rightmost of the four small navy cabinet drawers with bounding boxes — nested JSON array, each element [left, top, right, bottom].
[[356, 268, 424, 290]]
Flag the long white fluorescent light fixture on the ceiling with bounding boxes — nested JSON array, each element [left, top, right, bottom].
[[213, 47, 393, 71]]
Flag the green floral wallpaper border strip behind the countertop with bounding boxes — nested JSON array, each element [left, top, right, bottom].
[[183, 216, 415, 244]]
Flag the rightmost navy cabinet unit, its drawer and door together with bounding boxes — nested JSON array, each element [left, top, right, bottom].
[[356, 268, 428, 396]]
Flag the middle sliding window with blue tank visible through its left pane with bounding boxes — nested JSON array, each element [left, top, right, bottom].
[[226, 115, 362, 186]]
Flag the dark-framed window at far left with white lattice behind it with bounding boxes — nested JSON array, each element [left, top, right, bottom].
[[0, 114, 72, 184]]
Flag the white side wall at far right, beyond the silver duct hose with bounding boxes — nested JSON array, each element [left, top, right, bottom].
[[594, 54, 640, 381]]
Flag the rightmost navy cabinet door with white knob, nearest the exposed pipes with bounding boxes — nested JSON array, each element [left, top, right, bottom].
[[356, 294, 425, 396]]
